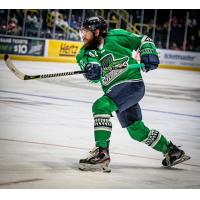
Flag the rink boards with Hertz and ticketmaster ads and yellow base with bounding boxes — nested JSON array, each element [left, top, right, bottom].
[[0, 35, 200, 71]]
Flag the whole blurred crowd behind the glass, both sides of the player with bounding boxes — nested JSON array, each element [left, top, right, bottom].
[[0, 10, 200, 52]]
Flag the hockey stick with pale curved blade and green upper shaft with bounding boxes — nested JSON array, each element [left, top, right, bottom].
[[4, 54, 144, 80]]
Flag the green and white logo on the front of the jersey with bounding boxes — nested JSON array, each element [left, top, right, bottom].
[[99, 53, 129, 86]]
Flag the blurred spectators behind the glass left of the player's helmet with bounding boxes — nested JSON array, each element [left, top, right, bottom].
[[0, 10, 80, 41]]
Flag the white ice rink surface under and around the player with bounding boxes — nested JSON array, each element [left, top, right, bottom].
[[0, 61, 200, 189]]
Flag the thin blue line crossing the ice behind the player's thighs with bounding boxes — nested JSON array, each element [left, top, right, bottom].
[[0, 90, 200, 118]]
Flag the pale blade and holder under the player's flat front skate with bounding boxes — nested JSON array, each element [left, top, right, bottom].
[[78, 162, 111, 173]]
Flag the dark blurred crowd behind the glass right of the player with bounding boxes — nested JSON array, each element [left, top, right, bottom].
[[128, 9, 200, 52]]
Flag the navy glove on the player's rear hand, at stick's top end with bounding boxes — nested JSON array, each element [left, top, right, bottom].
[[141, 54, 160, 72]]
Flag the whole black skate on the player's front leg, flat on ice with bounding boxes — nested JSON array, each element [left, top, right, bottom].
[[79, 147, 111, 172]]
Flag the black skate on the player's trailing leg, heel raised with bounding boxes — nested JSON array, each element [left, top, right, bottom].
[[162, 142, 190, 167]]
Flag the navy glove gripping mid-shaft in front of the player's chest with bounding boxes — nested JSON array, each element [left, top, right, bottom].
[[85, 63, 102, 81]]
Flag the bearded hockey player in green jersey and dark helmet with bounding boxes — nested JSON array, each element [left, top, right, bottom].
[[76, 17, 190, 171]]
